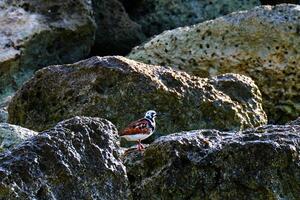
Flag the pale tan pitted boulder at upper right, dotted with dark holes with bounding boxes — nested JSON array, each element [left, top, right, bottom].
[[128, 4, 300, 123]]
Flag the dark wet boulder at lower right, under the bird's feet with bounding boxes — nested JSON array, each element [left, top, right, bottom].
[[124, 125, 300, 200]]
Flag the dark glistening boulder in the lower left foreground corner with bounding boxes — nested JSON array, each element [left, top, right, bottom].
[[0, 117, 130, 200]]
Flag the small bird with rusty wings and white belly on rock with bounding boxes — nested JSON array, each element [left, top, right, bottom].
[[119, 110, 157, 151]]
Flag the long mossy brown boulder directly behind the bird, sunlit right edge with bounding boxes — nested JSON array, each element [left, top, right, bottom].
[[8, 56, 266, 135]]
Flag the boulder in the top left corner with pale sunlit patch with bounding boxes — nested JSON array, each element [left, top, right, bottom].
[[0, 0, 96, 105]]
